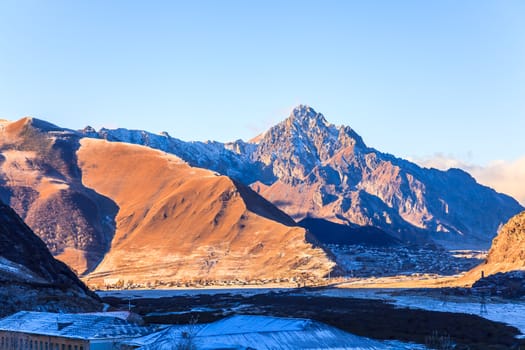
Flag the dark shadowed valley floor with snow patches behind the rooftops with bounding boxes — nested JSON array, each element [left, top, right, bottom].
[[99, 288, 525, 350]]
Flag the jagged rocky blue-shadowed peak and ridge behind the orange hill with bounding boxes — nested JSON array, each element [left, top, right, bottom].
[[80, 105, 523, 248]]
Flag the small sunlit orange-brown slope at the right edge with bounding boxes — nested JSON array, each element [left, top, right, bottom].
[[459, 211, 525, 284]]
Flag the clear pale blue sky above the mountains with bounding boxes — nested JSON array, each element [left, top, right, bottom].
[[0, 0, 525, 164]]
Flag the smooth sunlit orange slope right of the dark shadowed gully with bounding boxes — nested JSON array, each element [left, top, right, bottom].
[[77, 139, 333, 284]]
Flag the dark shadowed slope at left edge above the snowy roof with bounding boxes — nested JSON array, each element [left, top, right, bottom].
[[0, 202, 101, 316]]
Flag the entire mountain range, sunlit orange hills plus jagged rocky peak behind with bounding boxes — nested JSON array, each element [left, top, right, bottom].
[[0, 105, 523, 285]]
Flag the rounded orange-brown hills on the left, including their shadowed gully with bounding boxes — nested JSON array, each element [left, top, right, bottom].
[[0, 118, 334, 286]]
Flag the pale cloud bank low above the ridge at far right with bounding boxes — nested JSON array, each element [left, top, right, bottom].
[[412, 153, 525, 205]]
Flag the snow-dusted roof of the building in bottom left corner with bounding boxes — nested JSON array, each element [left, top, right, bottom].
[[0, 311, 156, 339]]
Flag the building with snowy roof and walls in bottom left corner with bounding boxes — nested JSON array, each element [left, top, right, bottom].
[[0, 311, 158, 350]]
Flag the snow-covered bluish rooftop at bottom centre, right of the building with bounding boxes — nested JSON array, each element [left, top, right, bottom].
[[128, 315, 424, 350]]
